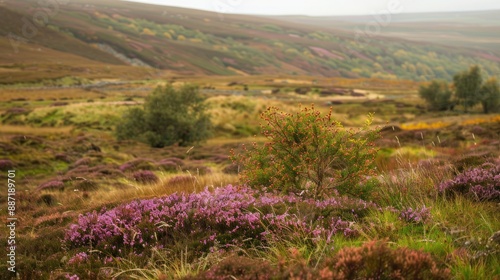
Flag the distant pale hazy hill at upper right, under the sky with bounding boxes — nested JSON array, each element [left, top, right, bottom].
[[273, 10, 500, 57]]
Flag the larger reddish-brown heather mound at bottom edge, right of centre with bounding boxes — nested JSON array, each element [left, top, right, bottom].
[[320, 241, 451, 279]]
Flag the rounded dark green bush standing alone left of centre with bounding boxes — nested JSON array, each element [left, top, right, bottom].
[[116, 84, 211, 148]]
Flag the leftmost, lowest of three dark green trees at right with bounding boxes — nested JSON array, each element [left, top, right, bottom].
[[418, 80, 453, 111]]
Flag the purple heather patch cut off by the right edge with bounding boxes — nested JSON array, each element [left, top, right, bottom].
[[438, 162, 500, 202]]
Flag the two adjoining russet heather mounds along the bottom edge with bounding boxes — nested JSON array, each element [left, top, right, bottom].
[[187, 241, 451, 280]]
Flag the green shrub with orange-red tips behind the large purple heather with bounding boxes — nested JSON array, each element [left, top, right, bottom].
[[233, 106, 378, 198]]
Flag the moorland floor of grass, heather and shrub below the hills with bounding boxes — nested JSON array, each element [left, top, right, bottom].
[[0, 80, 500, 279]]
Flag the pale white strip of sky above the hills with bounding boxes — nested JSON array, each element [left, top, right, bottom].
[[125, 0, 500, 16]]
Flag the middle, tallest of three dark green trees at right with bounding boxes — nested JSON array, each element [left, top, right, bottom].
[[453, 66, 482, 112]]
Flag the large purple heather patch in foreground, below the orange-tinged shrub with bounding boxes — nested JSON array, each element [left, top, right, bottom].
[[65, 185, 375, 256]]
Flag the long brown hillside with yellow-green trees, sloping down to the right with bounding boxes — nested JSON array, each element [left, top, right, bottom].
[[0, 0, 500, 82]]
